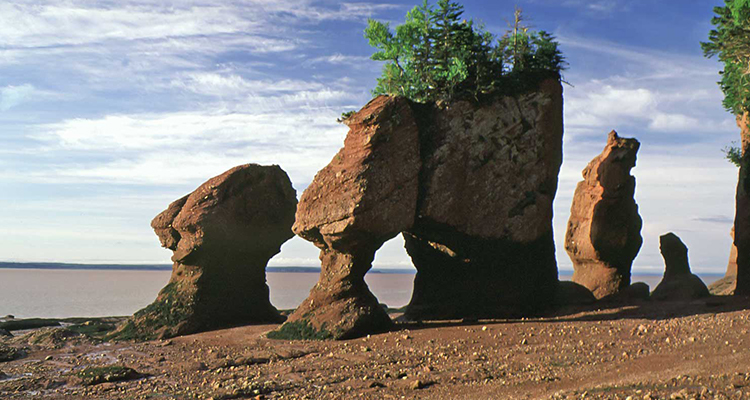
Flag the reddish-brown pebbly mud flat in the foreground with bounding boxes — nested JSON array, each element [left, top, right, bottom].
[[0, 297, 750, 399]]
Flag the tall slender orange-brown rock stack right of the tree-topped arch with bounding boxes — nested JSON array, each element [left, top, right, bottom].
[[565, 131, 643, 298]]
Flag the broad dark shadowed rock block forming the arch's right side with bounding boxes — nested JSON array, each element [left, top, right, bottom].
[[404, 80, 563, 320]]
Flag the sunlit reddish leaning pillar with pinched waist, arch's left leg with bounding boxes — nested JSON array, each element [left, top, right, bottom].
[[270, 96, 420, 339]]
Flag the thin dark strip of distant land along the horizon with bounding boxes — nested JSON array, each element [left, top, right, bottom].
[[0, 262, 417, 275]]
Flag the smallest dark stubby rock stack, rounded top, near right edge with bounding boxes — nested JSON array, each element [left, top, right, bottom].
[[651, 232, 710, 301]]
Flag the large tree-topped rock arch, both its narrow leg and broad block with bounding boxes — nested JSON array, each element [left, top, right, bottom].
[[269, 80, 562, 338]]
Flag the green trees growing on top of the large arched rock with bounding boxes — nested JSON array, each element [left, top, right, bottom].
[[365, 0, 565, 102]]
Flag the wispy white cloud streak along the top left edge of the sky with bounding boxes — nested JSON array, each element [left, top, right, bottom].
[[0, 0, 399, 48]]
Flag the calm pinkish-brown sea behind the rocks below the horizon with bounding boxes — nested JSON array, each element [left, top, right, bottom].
[[0, 269, 720, 318]]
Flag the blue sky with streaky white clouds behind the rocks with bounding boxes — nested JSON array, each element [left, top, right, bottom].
[[0, 0, 739, 273]]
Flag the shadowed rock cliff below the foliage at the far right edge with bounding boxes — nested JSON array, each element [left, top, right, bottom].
[[734, 112, 750, 295]]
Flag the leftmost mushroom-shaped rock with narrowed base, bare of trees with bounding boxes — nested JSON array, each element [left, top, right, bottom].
[[113, 164, 297, 339]]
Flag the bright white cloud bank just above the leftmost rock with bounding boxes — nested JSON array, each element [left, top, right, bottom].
[[25, 106, 346, 188]]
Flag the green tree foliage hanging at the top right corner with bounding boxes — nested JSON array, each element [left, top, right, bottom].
[[701, 0, 750, 115]]
